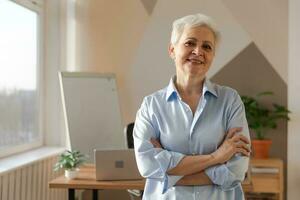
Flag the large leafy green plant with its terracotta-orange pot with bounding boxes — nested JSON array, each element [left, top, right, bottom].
[[241, 92, 290, 158]]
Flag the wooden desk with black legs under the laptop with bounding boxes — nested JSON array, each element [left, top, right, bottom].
[[49, 165, 252, 200]]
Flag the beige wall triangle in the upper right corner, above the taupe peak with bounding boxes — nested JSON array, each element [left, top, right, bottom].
[[222, 0, 288, 83]]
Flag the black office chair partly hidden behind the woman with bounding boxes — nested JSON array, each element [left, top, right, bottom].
[[124, 122, 143, 200]]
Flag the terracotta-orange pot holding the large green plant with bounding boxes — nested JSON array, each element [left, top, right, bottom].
[[251, 140, 272, 159]]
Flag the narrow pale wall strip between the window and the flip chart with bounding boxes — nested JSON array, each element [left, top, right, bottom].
[[43, 0, 68, 145]]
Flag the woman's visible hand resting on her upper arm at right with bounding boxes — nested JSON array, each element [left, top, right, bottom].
[[211, 128, 250, 164]]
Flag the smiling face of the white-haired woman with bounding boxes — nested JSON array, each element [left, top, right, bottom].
[[169, 26, 215, 79]]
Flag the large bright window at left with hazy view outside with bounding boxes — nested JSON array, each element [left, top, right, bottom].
[[0, 0, 43, 157]]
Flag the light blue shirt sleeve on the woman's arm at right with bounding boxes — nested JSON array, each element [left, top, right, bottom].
[[205, 92, 250, 190]]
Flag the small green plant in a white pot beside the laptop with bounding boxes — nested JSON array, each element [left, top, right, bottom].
[[54, 150, 87, 179]]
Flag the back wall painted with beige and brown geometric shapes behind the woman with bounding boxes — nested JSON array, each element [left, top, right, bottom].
[[77, 0, 288, 198]]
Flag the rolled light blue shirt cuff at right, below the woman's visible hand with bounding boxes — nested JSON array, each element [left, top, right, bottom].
[[205, 164, 240, 191]]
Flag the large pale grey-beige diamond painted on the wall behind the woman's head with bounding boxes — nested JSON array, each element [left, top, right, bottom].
[[124, 0, 251, 114]]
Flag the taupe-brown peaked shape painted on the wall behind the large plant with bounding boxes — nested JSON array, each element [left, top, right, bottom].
[[211, 43, 287, 197]]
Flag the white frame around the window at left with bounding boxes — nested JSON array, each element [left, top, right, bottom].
[[0, 0, 45, 158]]
